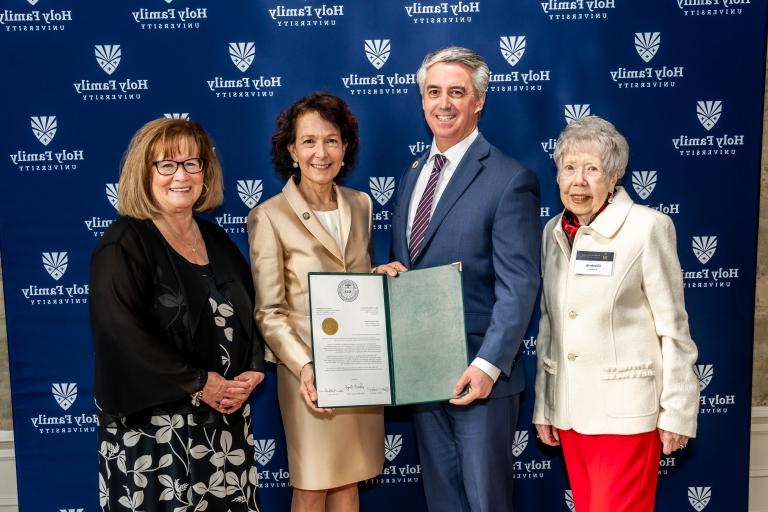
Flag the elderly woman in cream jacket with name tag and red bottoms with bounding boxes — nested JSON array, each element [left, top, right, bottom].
[[533, 116, 699, 512]]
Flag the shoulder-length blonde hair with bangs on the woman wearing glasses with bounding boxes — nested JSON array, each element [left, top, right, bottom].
[[117, 118, 224, 219]]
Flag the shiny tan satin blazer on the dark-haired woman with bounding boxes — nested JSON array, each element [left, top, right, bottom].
[[248, 179, 373, 376]]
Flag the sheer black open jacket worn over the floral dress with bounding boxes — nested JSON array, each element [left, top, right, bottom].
[[88, 217, 264, 424]]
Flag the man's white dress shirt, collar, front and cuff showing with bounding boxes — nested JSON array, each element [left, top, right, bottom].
[[405, 128, 501, 382]]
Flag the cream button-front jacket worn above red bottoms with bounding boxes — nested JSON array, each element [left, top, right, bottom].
[[533, 187, 699, 437]]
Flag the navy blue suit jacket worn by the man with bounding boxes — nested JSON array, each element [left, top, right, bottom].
[[391, 134, 541, 397]]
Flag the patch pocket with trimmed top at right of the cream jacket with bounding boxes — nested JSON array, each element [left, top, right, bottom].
[[603, 363, 659, 418]]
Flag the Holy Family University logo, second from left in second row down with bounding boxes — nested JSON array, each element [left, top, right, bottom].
[[205, 41, 283, 99]]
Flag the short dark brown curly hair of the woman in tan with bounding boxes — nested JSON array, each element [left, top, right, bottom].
[[270, 92, 360, 179]]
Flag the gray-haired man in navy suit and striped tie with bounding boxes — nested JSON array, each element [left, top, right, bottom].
[[377, 47, 541, 512]]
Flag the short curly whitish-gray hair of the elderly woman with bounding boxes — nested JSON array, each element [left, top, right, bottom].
[[553, 116, 629, 180]]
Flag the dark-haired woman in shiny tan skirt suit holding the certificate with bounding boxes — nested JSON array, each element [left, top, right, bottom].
[[248, 93, 384, 511]]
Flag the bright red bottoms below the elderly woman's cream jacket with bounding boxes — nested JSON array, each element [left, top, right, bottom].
[[560, 430, 661, 512]]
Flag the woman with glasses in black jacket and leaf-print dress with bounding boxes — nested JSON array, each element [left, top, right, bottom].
[[89, 119, 264, 512]]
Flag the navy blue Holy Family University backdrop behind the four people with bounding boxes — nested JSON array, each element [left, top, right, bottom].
[[0, 0, 766, 512]]
